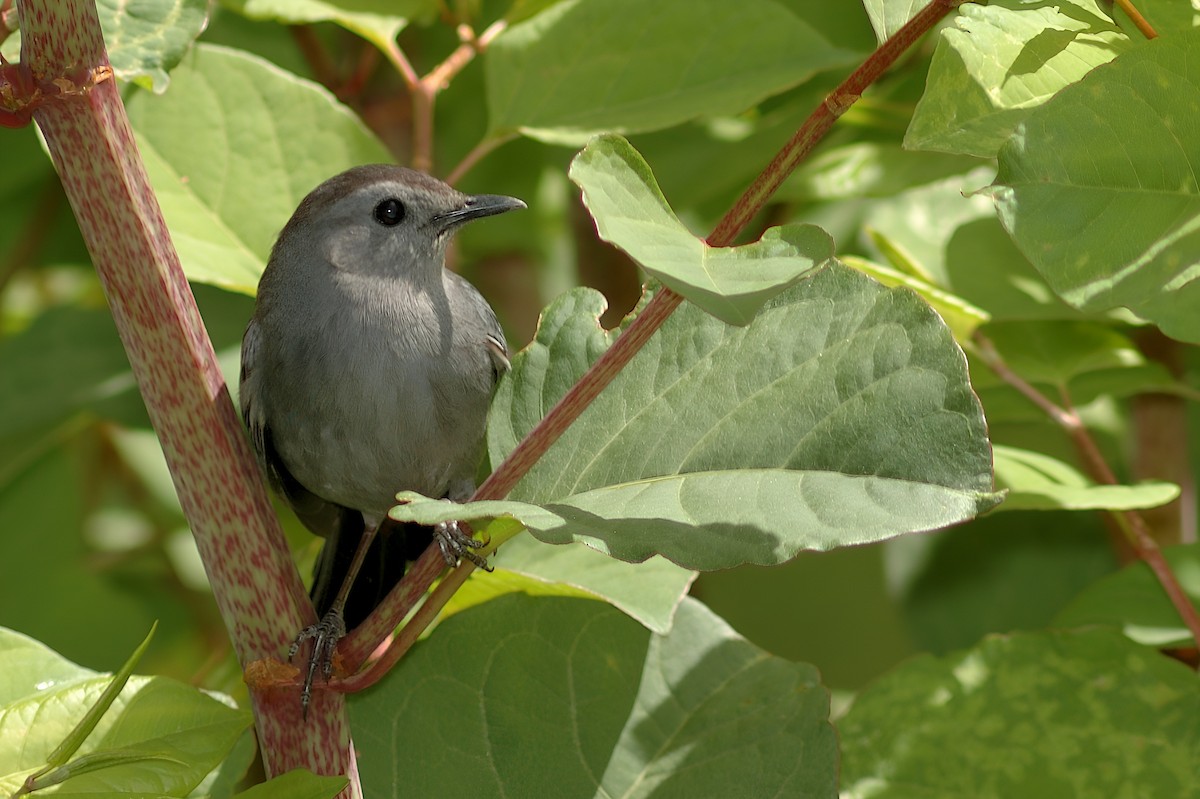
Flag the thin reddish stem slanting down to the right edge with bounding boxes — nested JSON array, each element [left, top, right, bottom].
[[973, 332, 1200, 645]]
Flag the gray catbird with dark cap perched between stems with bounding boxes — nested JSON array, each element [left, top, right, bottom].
[[240, 164, 524, 705]]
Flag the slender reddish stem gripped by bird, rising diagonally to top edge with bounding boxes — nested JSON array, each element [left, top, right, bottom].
[[338, 0, 962, 690]]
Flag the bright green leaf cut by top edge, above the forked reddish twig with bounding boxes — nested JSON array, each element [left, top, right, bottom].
[[221, 0, 438, 50]]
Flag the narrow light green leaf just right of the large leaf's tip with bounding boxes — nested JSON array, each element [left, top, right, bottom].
[[992, 444, 1180, 510]]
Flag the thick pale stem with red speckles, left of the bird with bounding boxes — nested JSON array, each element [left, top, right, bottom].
[[19, 0, 356, 782]]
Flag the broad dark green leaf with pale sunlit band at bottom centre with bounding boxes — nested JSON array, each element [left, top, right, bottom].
[[349, 596, 838, 799]]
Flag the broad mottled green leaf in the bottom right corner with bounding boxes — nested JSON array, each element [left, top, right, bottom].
[[838, 630, 1200, 799]]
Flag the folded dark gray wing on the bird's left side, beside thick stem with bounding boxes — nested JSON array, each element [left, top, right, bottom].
[[238, 320, 350, 537]]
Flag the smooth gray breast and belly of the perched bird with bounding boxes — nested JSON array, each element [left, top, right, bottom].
[[266, 275, 493, 516]]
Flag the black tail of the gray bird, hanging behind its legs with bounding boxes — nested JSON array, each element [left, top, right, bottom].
[[310, 512, 433, 630]]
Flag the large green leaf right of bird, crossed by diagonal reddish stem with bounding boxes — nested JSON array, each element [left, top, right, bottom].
[[472, 265, 998, 569]]
